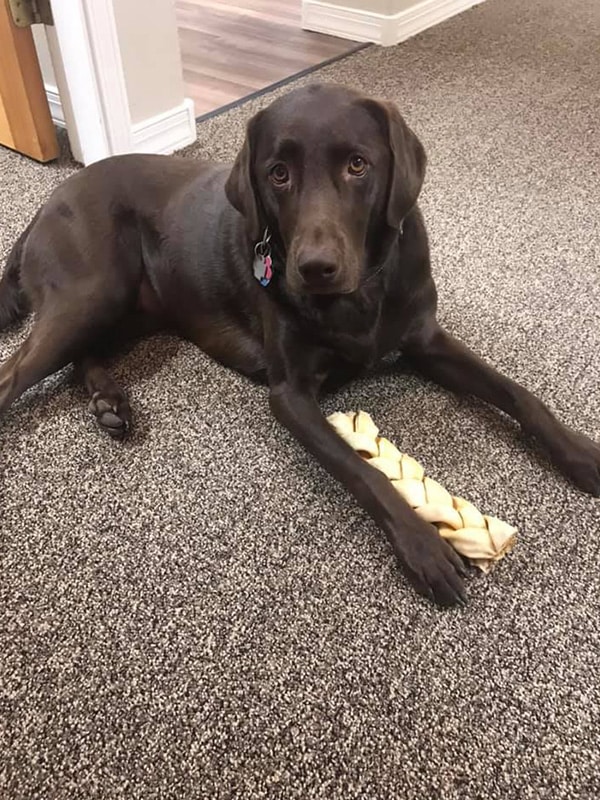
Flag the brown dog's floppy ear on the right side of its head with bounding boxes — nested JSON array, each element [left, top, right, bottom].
[[364, 99, 427, 228]]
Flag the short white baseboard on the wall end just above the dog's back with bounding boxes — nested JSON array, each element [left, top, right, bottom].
[[131, 97, 196, 155]]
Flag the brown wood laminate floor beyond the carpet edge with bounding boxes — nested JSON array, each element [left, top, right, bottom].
[[175, 0, 357, 116]]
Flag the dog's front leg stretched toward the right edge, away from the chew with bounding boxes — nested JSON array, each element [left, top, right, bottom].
[[403, 326, 600, 496]]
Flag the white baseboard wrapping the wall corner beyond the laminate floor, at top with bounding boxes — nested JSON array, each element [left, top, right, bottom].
[[302, 0, 484, 46]]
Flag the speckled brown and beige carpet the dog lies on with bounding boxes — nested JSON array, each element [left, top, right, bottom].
[[0, 0, 600, 800]]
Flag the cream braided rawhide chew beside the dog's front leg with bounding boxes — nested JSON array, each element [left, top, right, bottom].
[[328, 411, 517, 573]]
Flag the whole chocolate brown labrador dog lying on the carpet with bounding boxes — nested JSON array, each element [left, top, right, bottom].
[[0, 85, 600, 605]]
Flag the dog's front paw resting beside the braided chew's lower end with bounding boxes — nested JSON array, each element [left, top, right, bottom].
[[400, 522, 467, 606]]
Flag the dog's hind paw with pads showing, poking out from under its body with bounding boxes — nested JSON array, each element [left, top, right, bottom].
[[76, 355, 131, 439]]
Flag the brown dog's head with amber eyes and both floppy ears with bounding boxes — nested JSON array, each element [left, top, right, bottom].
[[225, 84, 425, 294]]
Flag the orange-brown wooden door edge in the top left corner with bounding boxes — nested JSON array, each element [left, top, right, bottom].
[[0, 0, 58, 161]]
